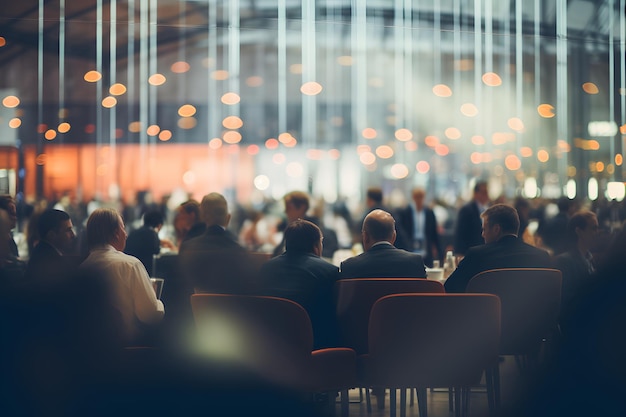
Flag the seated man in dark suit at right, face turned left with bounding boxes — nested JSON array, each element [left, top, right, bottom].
[[444, 204, 552, 293]]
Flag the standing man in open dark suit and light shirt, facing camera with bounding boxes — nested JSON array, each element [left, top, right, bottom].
[[396, 187, 444, 267]]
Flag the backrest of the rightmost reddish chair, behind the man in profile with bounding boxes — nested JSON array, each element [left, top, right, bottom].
[[466, 268, 561, 355]]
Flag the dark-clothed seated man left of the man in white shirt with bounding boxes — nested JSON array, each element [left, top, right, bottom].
[[25, 209, 77, 285]]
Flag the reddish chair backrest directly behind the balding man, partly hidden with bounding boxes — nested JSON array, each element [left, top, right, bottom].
[[335, 278, 445, 354]]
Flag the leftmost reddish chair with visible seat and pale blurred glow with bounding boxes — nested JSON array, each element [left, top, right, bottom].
[[191, 294, 356, 416]]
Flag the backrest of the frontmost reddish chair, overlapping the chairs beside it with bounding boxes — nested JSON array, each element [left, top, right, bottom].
[[368, 294, 500, 388]]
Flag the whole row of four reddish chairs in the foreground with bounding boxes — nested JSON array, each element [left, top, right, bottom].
[[191, 269, 561, 417]]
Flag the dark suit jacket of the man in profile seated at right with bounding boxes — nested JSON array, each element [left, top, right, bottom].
[[444, 235, 552, 292]]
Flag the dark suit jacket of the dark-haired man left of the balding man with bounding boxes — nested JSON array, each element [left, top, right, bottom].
[[259, 252, 339, 349]]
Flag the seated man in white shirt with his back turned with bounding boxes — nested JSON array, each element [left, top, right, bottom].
[[81, 208, 165, 345]]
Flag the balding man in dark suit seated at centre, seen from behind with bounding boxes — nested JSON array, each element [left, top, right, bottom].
[[340, 210, 426, 279]]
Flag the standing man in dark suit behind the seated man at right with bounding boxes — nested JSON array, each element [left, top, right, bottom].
[[454, 181, 488, 255]]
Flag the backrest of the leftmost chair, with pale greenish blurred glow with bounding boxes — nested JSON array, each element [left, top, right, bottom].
[[186, 294, 313, 382]]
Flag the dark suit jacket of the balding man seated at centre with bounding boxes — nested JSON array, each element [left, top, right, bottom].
[[340, 243, 426, 279]]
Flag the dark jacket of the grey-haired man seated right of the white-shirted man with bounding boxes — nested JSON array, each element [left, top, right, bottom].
[[177, 226, 255, 294]]
